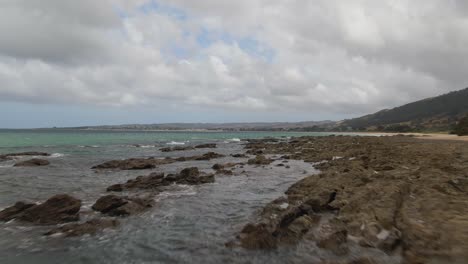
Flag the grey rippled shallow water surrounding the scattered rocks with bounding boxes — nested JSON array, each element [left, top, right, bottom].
[[0, 133, 398, 263]]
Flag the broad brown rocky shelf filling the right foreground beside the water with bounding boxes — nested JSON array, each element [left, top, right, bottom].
[[228, 136, 468, 263]]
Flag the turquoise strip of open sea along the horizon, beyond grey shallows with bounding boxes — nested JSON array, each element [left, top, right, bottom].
[[0, 129, 336, 148]]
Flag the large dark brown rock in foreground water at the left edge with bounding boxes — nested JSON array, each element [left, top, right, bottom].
[[0, 194, 81, 225]]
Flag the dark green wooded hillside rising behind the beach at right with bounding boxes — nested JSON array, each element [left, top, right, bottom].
[[338, 88, 468, 132]]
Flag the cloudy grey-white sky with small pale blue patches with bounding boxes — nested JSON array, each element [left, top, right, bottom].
[[0, 0, 468, 127]]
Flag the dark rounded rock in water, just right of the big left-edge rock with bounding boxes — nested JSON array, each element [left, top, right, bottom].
[[92, 195, 153, 216]]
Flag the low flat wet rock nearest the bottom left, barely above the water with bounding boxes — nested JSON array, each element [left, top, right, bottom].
[[44, 219, 119, 237]]
